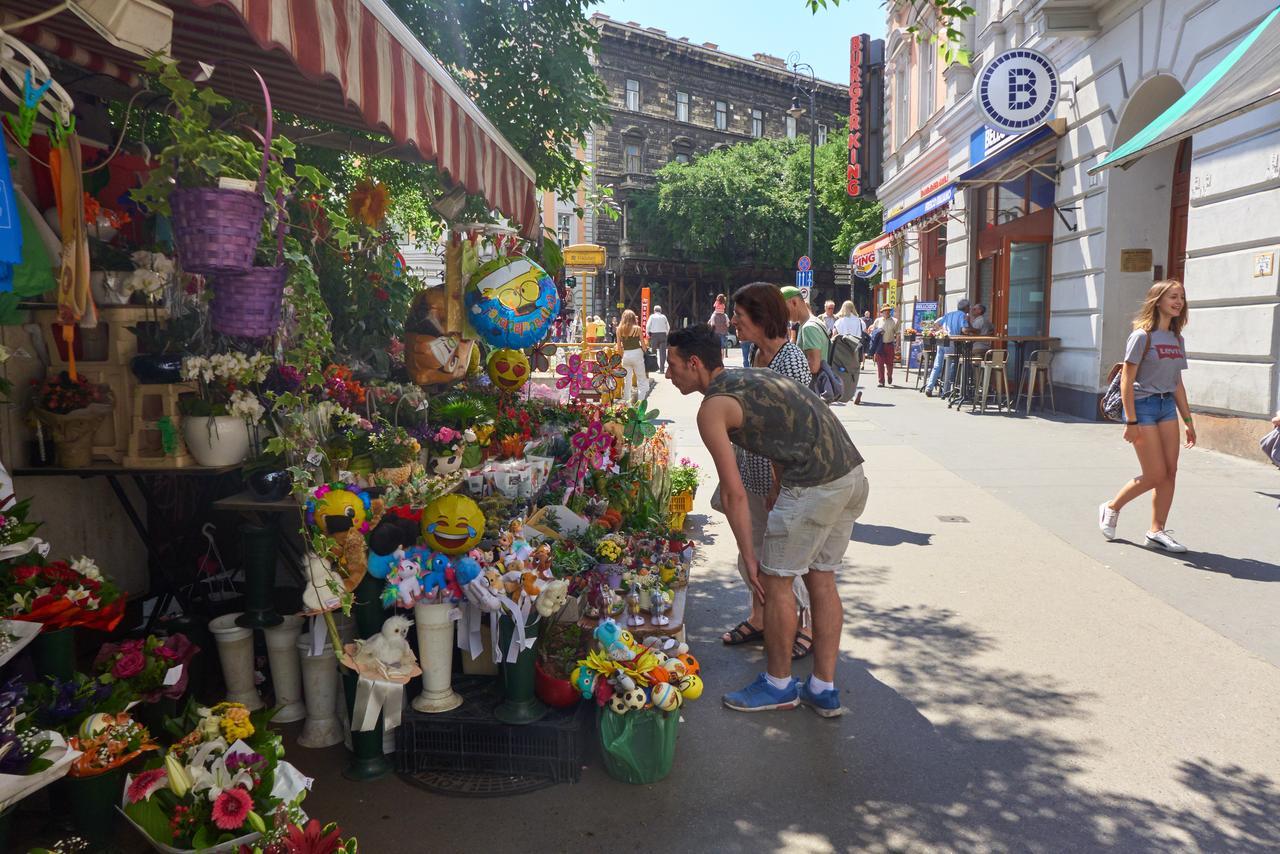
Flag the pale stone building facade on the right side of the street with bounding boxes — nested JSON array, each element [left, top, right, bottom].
[[878, 0, 1280, 453]]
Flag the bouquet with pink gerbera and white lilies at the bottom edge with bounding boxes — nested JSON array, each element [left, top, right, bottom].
[[124, 703, 310, 850]]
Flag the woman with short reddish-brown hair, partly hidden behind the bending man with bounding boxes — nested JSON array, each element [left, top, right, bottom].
[[712, 282, 813, 661]]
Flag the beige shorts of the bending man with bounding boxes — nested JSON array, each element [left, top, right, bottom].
[[760, 466, 870, 575]]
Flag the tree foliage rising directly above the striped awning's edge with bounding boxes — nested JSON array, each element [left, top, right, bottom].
[[389, 0, 609, 197]]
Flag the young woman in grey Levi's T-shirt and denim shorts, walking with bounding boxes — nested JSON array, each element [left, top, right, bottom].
[[1098, 279, 1196, 553]]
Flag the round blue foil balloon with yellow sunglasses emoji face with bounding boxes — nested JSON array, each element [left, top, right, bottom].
[[463, 256, 559, 350]]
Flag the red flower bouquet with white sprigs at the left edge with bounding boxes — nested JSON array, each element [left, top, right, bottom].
[[0, 557, 124, 631]]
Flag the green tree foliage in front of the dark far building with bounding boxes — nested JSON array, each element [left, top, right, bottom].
[[630, 133, 881, 273]]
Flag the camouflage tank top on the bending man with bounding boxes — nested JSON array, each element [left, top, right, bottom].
[[705, 367, 863, 487]]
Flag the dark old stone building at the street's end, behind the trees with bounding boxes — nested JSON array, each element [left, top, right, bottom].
[[563, 14, 849, 323]]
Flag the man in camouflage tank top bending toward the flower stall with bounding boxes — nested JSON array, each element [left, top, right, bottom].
[[667, 320, 869, 717]]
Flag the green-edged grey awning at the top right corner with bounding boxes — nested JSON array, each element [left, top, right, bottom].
[[1089, 8, 1280, 174]]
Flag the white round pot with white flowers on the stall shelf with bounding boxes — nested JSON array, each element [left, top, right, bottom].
[[179, 352, 271, 466]]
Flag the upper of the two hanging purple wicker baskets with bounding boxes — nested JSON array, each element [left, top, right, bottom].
[[169, 187, 266, 275]]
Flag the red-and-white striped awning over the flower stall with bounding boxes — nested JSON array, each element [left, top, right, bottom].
[[0, 0, 541, 237]]
